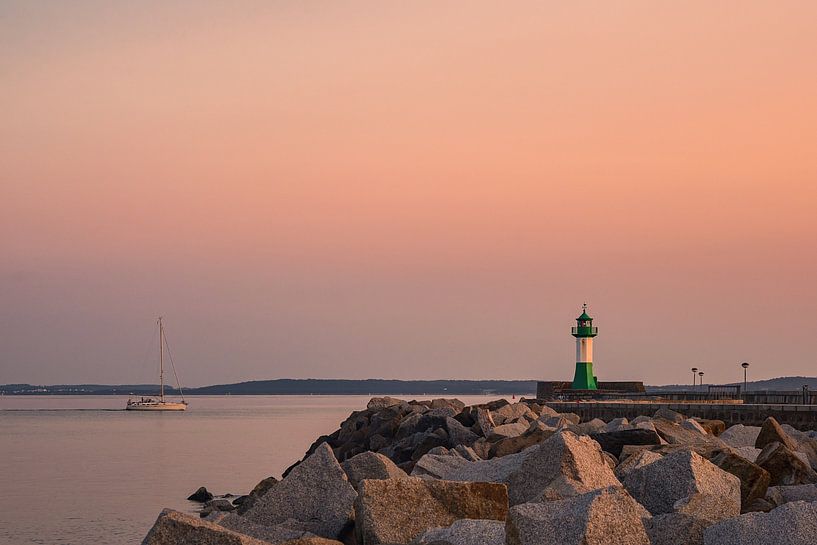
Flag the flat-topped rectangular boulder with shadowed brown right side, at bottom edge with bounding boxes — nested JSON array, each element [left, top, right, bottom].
[[355, 478, 508, 545]]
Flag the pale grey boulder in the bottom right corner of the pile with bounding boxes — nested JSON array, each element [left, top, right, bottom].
[[704, 501, 817, 545]]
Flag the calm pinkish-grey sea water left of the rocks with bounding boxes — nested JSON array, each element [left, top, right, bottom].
[[0, 396, 500, 545]]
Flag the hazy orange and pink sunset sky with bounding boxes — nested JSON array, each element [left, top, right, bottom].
[[0, 0, 817, 386]]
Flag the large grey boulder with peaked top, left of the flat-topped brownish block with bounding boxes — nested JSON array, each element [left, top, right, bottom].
[[244, 443, 357, 539]]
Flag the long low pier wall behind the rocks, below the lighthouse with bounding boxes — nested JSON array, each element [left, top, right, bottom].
[[540, 401, 817, 430]]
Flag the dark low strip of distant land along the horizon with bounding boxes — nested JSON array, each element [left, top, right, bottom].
[[0, 376, 817, 396]]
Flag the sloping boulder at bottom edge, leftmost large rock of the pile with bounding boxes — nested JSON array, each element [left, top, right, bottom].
[[142, 509, 269, 545]]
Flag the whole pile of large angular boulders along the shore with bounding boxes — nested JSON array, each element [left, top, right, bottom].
[[143, 397, 817, 545]]
